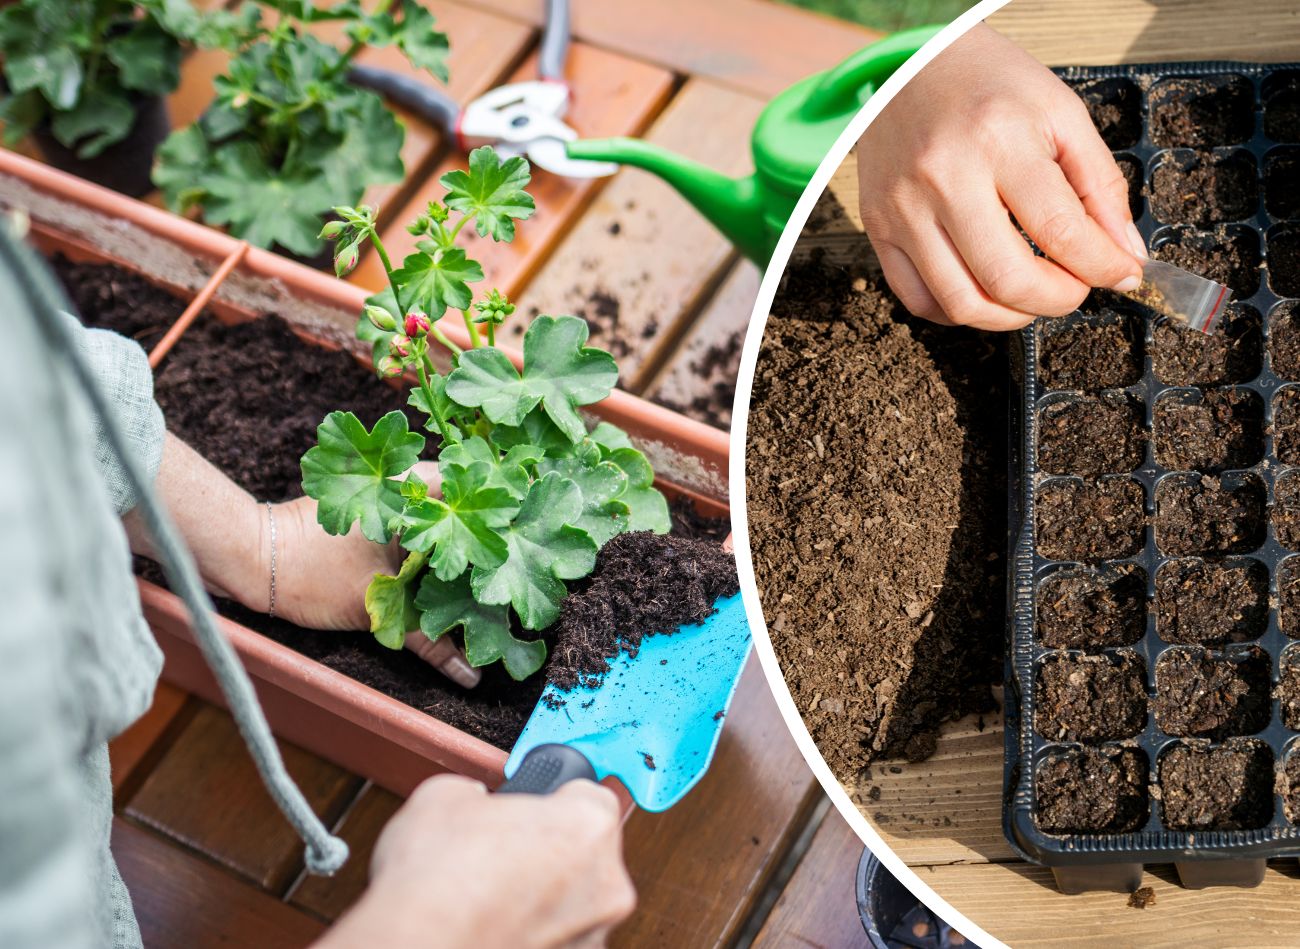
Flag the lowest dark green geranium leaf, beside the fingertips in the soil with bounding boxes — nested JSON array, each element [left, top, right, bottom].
[[415, 573, 546, 681]]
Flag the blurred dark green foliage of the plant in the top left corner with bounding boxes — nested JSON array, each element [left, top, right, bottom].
[[0, 0, 257, 159]]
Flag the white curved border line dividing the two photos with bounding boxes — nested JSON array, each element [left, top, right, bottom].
[[728, 0, 1011, 949]]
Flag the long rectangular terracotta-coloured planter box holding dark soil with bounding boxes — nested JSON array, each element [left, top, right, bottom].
[[0, 150, 728, 794]]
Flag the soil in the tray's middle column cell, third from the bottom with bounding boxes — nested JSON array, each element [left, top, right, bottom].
[[1156, 558, 1269, 646]]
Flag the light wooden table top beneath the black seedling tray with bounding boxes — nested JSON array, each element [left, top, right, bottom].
[[797, 0, 1300, 949]]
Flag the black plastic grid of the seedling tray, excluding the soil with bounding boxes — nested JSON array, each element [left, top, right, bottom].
[[1002, 62, 1300, 893]]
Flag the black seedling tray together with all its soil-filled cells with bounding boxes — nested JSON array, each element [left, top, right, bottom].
[[1004, 62, 1300, 892]]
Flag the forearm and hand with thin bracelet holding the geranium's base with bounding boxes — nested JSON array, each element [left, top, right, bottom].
[[125, 433, 482, 688]]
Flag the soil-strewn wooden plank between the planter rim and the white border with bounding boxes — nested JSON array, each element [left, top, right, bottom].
[[646, 254, 762, 430]]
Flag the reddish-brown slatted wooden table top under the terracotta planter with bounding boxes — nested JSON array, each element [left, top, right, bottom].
[[91, 0, 875, 949]]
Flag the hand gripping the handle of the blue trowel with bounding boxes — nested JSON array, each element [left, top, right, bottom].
[[319, 776, 636, 949]]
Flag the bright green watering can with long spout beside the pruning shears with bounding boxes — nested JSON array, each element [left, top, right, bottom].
[[567, 26, 943, 267]]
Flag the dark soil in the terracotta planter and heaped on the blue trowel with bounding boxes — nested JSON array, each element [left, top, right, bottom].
[[62, 257, 736, 749]]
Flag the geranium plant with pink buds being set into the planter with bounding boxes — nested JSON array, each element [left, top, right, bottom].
[[302, 148, 670, 679]]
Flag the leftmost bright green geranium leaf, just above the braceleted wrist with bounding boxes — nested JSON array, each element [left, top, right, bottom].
[[302, 412, 424, 543]]
